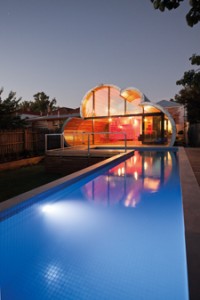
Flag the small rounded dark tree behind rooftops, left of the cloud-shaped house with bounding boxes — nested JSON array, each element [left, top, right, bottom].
[[31, 92, 56, 116]]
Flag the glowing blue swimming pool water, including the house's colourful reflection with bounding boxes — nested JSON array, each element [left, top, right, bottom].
[[0, 152, 188, 300]]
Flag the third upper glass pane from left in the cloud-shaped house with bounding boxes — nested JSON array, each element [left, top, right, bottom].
[[110, 88, 124, 116]]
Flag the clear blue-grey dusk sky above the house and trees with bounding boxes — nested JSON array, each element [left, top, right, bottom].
[[0, 0, 200, 108]]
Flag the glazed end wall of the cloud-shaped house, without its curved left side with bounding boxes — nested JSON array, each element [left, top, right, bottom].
[[77, 85, 172, 144]]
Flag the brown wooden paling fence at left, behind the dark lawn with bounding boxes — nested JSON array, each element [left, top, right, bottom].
[[0, 128, 57, 162]]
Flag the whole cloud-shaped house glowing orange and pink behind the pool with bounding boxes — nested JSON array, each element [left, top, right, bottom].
[[63, 84, 176, 146]]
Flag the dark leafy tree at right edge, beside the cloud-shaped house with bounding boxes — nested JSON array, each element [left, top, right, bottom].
[[175, 54, 200, 124]]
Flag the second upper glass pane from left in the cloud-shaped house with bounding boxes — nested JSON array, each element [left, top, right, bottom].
[[94, 87, 108, 117]]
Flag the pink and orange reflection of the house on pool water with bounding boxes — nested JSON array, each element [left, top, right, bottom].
[[83, 151, 172, 207]]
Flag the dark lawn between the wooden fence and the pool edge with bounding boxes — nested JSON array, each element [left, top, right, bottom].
[[0, 163, 62, 202]]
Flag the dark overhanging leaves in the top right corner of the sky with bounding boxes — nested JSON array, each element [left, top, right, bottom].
[[151, 0, 200, 27]]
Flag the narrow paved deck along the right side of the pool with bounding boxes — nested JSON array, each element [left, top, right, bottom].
[[179, 148, 200, 300]]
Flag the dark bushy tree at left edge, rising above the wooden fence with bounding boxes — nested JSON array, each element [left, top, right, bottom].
[[0, 88, 25, 129]]
